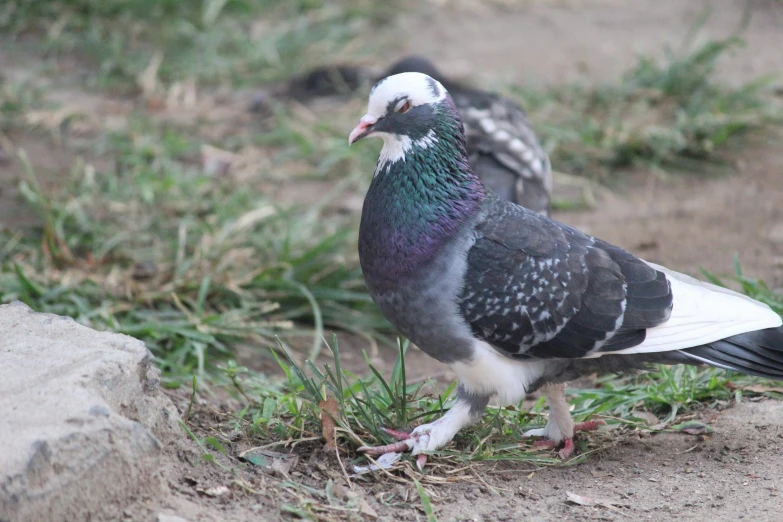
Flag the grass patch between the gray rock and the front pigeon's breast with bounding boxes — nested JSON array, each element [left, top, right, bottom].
[[0, 97, 390, 379]]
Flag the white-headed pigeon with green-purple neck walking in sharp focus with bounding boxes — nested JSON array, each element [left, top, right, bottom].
[[348, 73, 783, 467]]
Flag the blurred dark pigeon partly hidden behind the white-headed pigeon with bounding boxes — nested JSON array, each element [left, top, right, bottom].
[[286, 56, 552, 216]]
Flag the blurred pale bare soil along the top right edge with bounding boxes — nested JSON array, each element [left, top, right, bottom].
[[396, 0, 783, 88]]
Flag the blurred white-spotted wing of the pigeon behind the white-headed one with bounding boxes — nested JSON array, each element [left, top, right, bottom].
[[452, 91, 552, 215]]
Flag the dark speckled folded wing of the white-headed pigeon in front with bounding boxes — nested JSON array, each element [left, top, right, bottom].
[[459, 195, 672, 358]]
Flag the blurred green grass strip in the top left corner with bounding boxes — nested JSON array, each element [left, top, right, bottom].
[[0, 0, 394, 85]]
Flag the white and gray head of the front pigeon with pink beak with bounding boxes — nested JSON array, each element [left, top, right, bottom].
[[348, 72, 459, 155]]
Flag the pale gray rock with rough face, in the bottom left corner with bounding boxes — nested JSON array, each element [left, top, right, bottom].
[[0, 302, 177, 522]]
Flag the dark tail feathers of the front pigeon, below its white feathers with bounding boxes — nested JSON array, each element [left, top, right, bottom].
[[679, 327, 783, 380]]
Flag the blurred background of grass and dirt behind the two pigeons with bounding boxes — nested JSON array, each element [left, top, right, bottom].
[[0, 0, 783, 408]]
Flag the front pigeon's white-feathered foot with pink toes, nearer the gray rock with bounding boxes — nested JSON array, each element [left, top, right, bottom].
[[358, 414, 462, 471]]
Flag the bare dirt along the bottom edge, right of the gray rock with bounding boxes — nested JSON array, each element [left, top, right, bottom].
[[122, 388, 783, 522]]
